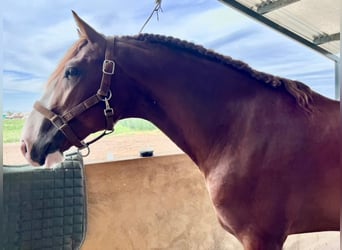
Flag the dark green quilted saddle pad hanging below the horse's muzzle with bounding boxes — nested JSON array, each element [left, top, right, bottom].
[[0, 154, 86, 250]]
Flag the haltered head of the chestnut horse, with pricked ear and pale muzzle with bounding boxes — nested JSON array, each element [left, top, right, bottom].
[[21, 12, 118, 168]]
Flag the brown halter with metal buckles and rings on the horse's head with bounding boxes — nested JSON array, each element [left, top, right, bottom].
[[34, 37, 115, 156]]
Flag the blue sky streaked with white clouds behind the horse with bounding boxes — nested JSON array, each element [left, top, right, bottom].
[[2, 0, 334, 112]]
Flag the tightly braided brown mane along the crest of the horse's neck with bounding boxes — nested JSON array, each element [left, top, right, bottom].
[[124, 34, 312, 112]]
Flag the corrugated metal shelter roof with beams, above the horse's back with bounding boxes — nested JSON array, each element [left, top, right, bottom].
[[220, 0, 341, 61]]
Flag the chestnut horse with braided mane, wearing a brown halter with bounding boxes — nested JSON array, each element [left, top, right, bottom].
[[21, 13, 341, 250]]
